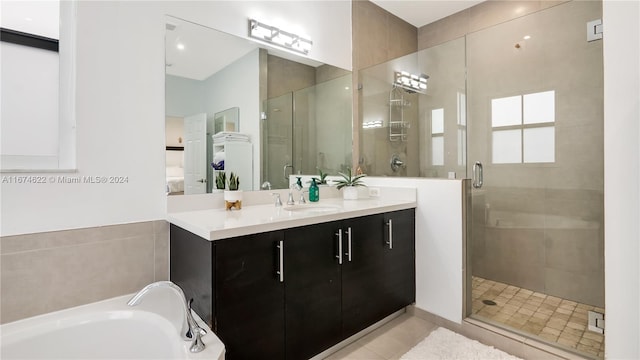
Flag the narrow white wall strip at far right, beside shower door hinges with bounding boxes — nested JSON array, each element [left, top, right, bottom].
[[603, 1, 640, 359]]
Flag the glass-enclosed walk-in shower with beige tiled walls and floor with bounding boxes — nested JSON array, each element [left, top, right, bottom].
[[359, 1, 605, 358]]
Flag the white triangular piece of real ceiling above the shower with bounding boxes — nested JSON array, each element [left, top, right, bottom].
[[371, 0, 482, 28]]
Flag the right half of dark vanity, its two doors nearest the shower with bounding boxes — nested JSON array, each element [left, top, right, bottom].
[[342, 209, 415, 338]]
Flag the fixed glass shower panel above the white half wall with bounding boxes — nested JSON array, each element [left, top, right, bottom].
[[359, 38, 467, 178]]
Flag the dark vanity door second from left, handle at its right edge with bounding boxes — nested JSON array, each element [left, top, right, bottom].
[[286, 223, 341, 360]]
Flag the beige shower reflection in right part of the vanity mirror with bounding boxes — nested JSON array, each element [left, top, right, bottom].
[[262, 56, 352, 189]]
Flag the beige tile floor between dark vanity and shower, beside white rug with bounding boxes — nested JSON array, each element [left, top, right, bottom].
[[326, 313, 438, 360]]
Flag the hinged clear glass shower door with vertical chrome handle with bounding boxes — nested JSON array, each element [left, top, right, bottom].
[[467, 1, 604, 356]]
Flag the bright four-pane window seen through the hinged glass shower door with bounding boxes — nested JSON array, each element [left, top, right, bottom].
[[491, 90, 555, 164]]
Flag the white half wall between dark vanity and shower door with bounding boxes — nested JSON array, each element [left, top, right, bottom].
[[365, 177, 466, 323]]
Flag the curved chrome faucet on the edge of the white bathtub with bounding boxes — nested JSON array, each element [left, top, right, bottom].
[[127, 281, 206, 353]]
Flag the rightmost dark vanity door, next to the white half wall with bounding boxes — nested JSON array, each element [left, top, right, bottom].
[[382, 209, 416, 312]]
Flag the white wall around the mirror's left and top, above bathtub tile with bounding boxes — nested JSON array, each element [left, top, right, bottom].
[[0, 1, 351, 236]]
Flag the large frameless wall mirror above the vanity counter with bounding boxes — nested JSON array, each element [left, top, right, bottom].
[[165, 16, 353, 195]]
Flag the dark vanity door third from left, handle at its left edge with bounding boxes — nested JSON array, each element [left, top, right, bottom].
[[342, 214, 389, 338]]
